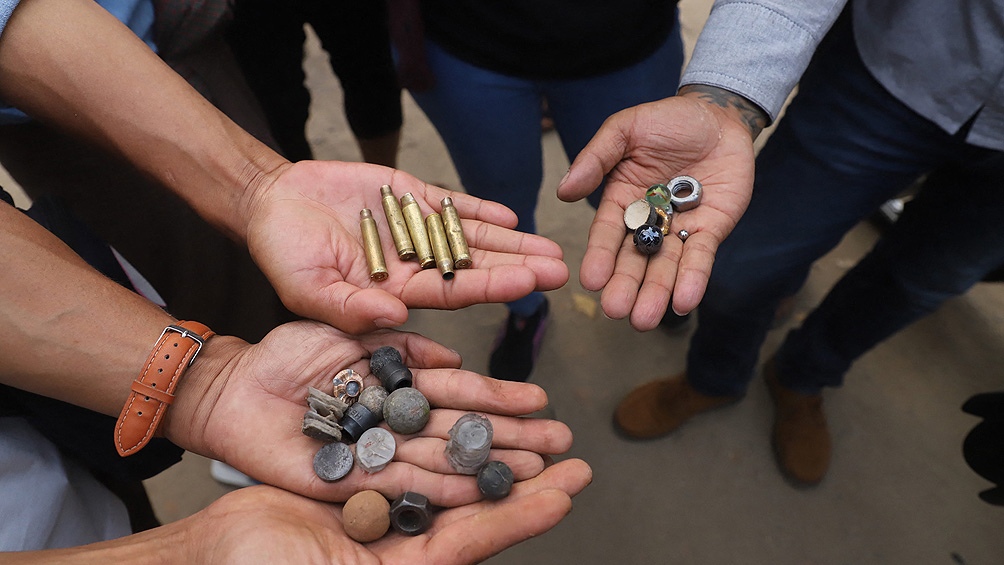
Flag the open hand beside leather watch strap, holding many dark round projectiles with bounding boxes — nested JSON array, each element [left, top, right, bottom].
[[167, 321, 572, 507]]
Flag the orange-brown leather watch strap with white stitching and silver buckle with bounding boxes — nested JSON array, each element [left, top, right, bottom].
[[115, 321, 215, 457]]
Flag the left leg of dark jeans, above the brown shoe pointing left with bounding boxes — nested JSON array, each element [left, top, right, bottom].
[[687, 13, 951, 395]]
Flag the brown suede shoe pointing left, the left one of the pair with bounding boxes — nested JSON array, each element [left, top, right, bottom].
[[613, 374, 739, 440]]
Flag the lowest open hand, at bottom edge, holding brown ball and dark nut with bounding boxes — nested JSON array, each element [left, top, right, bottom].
[[180, 460, 592, 565]]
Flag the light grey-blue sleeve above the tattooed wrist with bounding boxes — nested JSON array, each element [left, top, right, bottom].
[[681, 0, 846, 121]]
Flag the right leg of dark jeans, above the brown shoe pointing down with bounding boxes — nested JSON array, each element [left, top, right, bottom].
[[777, 148, 1004, 393]]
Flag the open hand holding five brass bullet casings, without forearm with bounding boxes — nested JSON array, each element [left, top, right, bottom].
[[237, 161, 568, 333]]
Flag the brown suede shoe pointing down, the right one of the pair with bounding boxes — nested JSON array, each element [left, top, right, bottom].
[[764, 358, 832, 487]]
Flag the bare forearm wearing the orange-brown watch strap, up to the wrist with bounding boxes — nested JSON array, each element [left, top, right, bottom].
[[0, 205, 237, 441]]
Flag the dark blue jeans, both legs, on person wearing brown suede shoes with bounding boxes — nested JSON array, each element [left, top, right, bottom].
[[687, 18, 1004, 395]]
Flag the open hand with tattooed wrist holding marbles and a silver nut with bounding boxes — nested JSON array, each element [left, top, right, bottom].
[[557, 90, 759, 330]]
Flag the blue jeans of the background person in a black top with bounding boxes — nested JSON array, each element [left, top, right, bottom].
[[412, 18, 683, 315]]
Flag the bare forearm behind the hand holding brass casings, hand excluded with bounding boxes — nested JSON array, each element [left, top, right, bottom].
[[0, 0, 287, 241]]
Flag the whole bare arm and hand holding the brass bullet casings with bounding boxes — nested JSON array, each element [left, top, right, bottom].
[[0, 0, 567, 332]]
